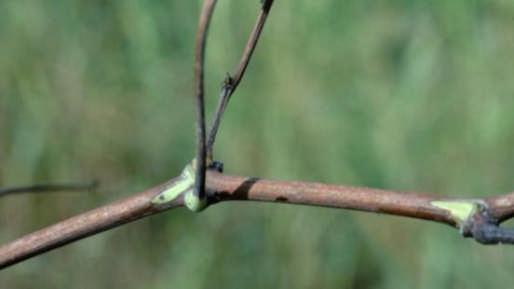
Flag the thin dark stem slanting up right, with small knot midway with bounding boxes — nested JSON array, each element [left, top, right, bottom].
[[207, 0, 273, 159]]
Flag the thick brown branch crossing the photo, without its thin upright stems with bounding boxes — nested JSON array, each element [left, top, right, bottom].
[[0, 170, 514, 269]]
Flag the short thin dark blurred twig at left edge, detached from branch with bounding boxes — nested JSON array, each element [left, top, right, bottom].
[[0, 181, 98, 197]]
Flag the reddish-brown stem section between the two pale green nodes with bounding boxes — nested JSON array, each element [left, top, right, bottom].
[[207, 172, 455, 225]]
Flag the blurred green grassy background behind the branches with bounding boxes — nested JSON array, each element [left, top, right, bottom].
[[0, 0, 514, 289]]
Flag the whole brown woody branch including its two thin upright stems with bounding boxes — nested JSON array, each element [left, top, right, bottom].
[[4, 0, 514, 269]]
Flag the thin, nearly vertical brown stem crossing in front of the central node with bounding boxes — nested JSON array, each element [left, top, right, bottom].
[[194, 0, 216, 199]]
